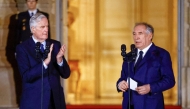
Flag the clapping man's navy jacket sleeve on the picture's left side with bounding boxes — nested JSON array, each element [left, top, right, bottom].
[[16, 45, 47, 83]]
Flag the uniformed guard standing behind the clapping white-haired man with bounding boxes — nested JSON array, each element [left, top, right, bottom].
[[16, 0, 50, 44]]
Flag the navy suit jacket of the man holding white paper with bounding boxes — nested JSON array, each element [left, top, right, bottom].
[[116, 44, 175, 109]]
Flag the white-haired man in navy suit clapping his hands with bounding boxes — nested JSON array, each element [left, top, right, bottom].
[[16, 13, 70, 109]]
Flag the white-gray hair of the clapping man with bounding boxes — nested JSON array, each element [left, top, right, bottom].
[[30, 13, 47, 31]]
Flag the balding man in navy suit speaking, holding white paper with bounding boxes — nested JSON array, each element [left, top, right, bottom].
[[116, 22, 175, 109]]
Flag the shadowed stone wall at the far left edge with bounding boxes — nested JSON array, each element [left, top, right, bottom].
[[0, 0, 19, 107]]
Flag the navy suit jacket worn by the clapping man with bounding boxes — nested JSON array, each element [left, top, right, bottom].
[[16, 38, 70, 109]]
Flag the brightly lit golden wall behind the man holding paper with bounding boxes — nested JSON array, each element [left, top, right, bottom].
[[68, 0, 178, 104]]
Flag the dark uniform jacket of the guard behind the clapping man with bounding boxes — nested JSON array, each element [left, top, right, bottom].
[[16, 10, 50, 44]]
